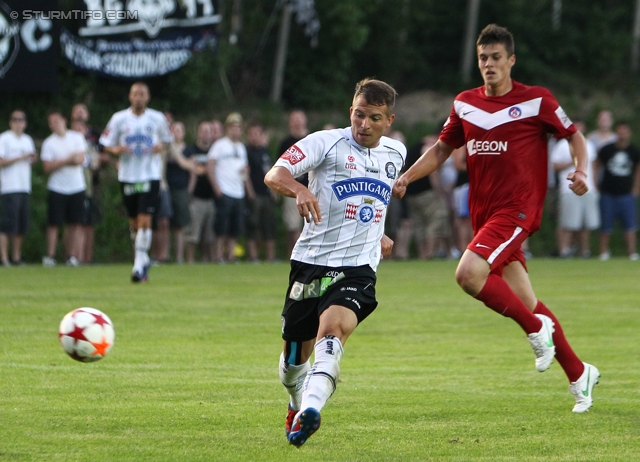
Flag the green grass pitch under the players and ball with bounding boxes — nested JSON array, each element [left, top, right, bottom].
[[0, 259, 640, 462]]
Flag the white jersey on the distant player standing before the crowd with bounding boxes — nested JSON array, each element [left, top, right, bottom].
[[100, 108, 173, 183]]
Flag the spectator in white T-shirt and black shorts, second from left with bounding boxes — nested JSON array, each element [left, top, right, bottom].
[[41, 110, 88, 266]]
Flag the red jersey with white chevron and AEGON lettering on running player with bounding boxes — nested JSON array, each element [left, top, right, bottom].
[[440, 81, 576, 233]]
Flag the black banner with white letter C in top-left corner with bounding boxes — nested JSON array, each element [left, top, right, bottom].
[[0, 0, 58, 92]]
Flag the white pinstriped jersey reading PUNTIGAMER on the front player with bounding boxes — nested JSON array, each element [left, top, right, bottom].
[[275, 127, 407, 271]]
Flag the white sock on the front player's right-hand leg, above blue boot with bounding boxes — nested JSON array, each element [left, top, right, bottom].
[[300, 335, 343, 411]]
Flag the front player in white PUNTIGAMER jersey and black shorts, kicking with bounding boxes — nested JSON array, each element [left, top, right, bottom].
[[265, 79, 406, 447]]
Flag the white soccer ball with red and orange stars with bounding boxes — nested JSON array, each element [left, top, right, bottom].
[[58, 308, 116, 363]]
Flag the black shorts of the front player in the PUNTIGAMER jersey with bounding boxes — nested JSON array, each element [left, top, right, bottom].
[[282, 260, 378, 342]]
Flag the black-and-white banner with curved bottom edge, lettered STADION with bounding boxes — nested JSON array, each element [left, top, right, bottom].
[[61, 0, 221, 79]]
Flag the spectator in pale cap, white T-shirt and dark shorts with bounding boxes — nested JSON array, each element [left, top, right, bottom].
[[207, 112, 255, 262]]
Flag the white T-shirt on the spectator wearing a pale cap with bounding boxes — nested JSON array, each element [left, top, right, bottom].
[[208, 136, 249, 199]]
